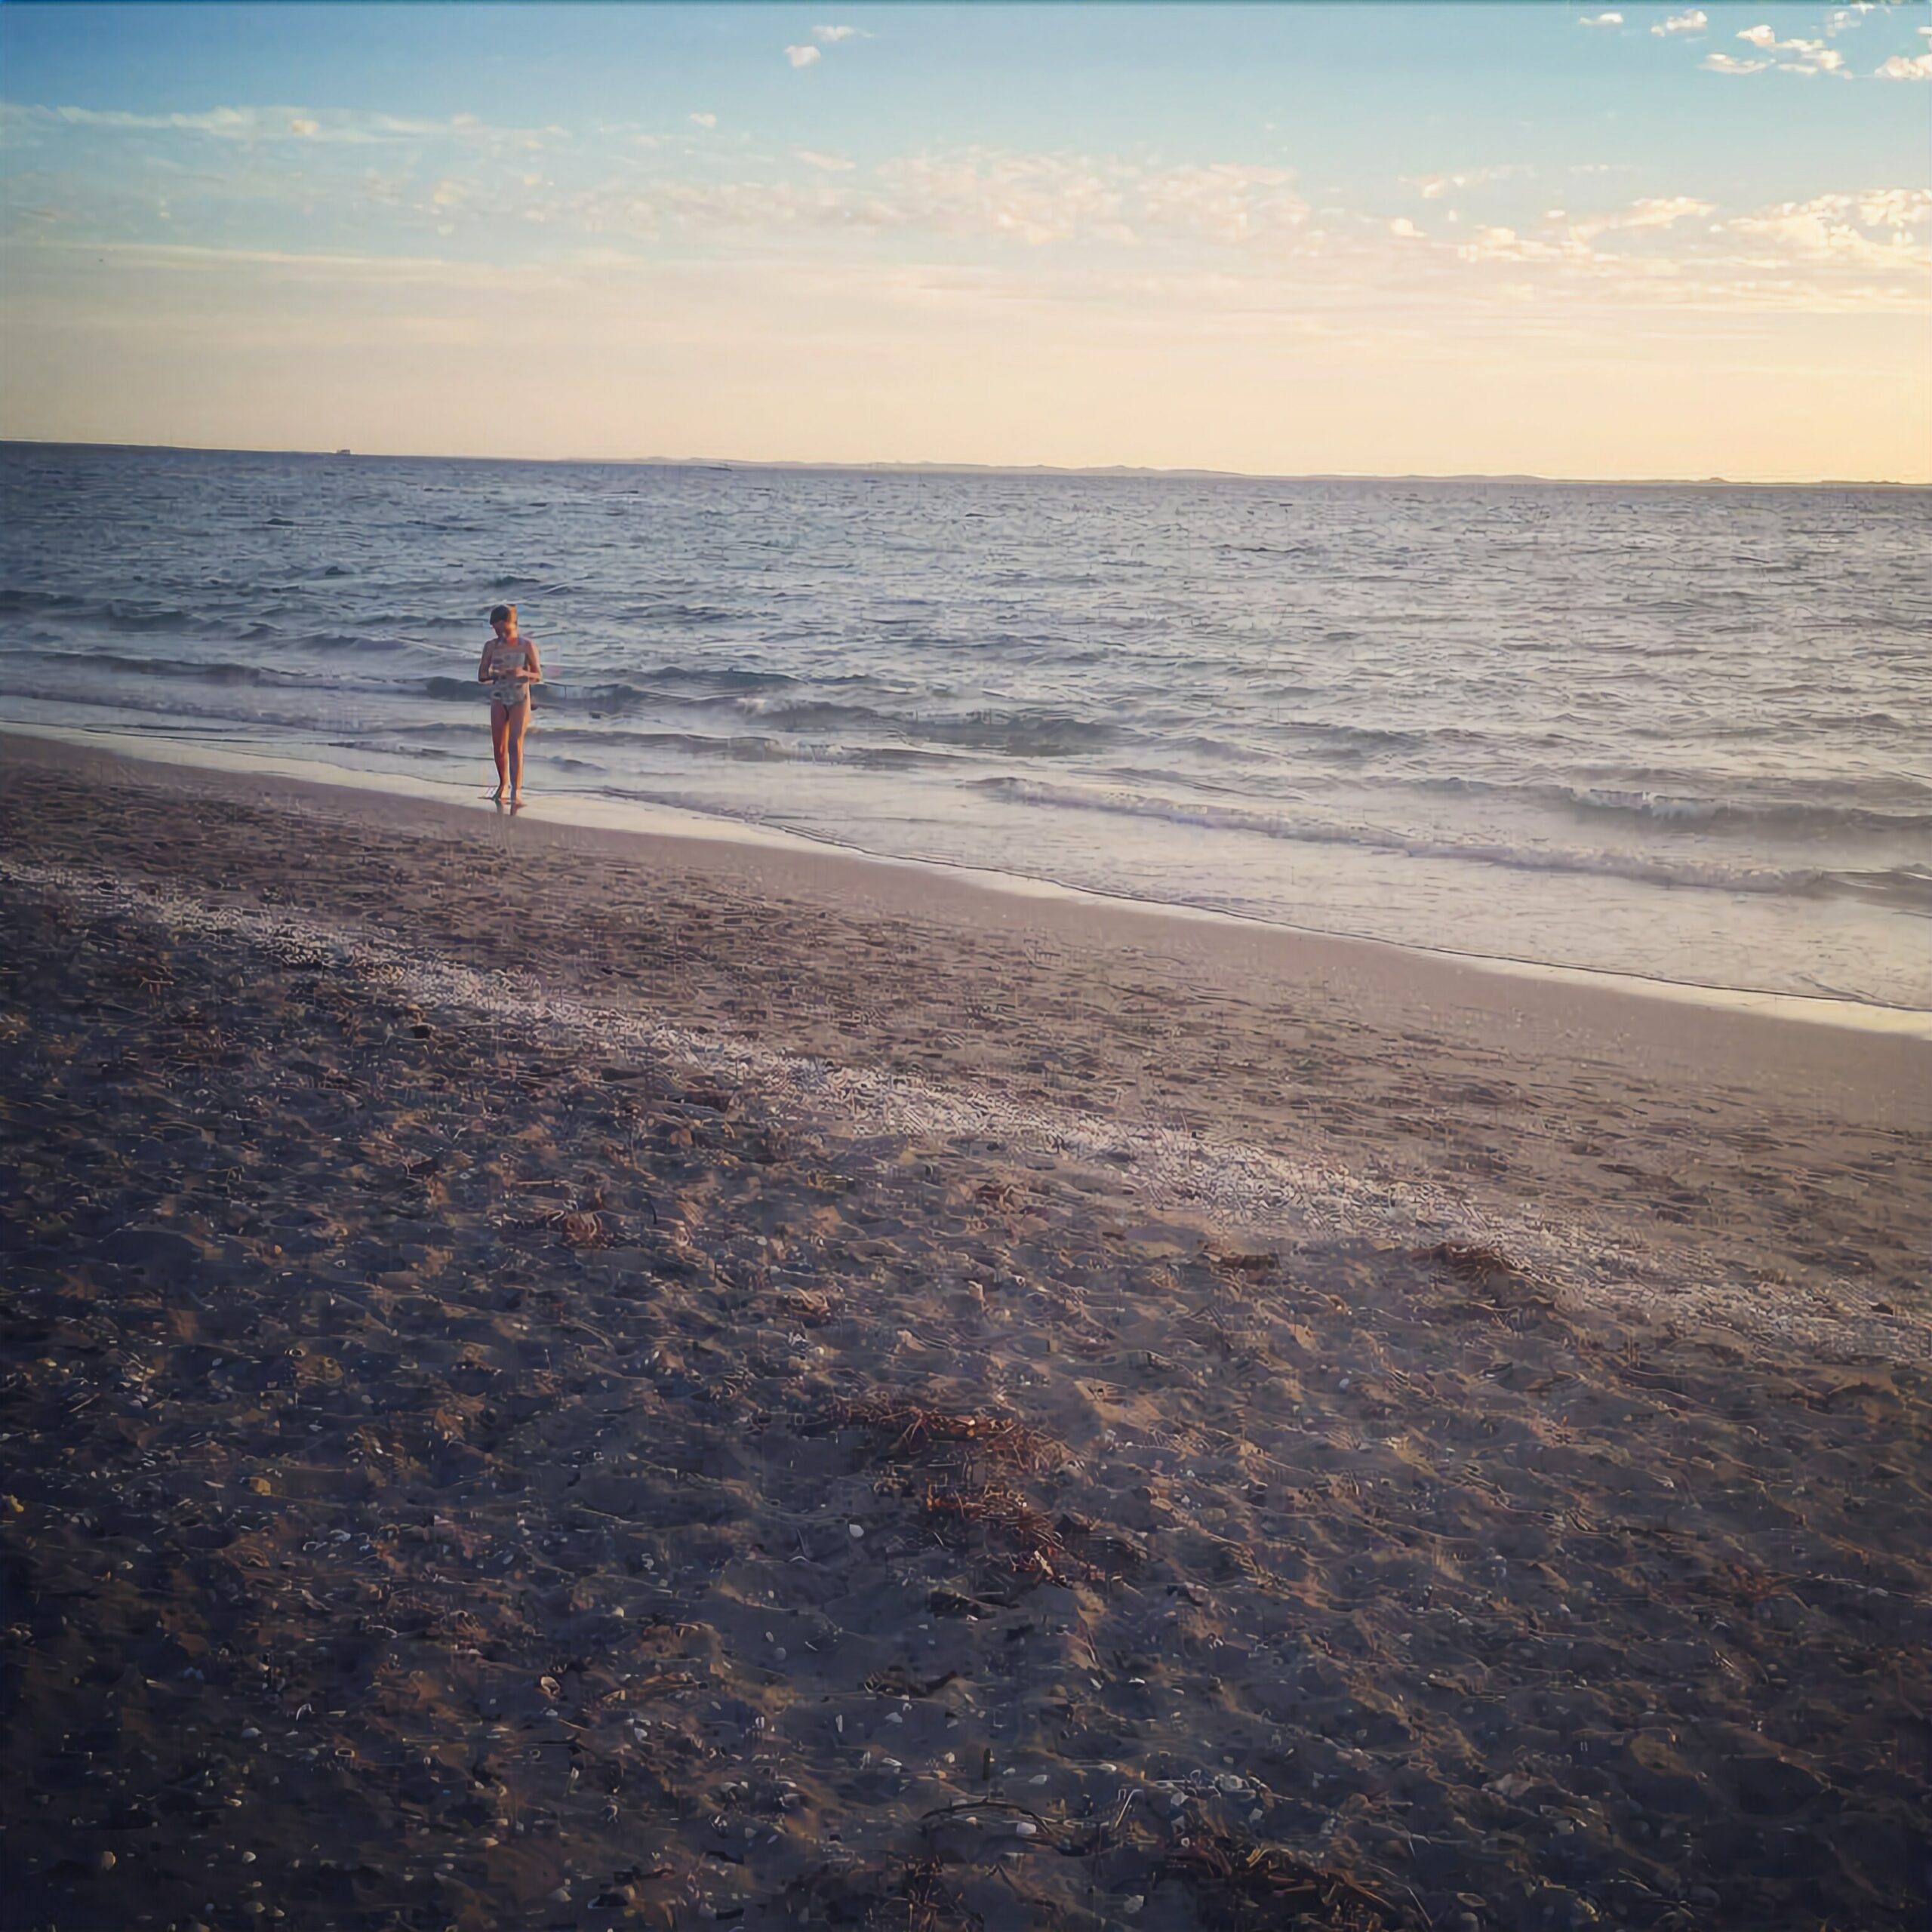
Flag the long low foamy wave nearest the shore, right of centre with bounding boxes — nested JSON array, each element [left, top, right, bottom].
[[970, 779, 1832, 897]]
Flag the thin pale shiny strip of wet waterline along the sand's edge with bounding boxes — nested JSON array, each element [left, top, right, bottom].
[[0, 721, 1932, 1041]]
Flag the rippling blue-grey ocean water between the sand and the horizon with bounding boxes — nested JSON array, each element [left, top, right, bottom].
[[0, 445, 1932, 1008]]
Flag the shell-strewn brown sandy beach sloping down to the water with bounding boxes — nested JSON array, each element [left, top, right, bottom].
[[0, 734, 1932, 1932]]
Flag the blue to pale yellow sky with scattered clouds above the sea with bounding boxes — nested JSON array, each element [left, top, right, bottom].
[[0, 0, 1932, 481]]
